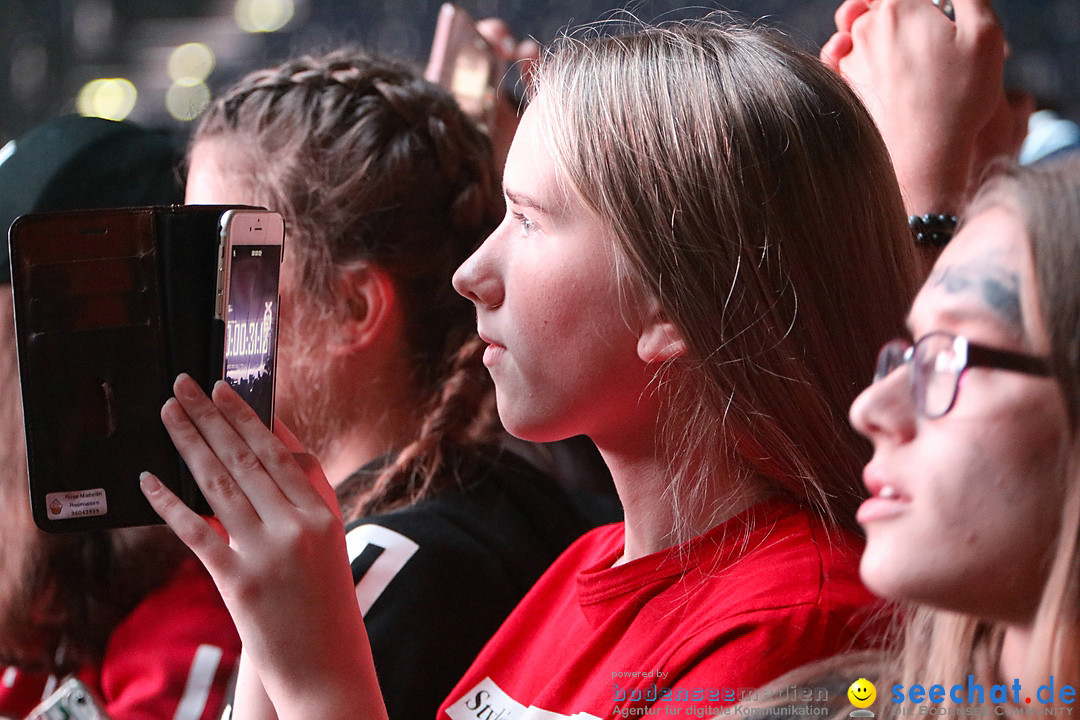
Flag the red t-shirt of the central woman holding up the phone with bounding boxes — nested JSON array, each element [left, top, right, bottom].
[[440, 500, 879, 720]]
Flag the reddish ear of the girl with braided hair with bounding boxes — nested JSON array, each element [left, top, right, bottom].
[[330, 263, 397, 354]]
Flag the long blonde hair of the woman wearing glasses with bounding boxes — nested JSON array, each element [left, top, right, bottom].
[[895, 158, 1080, 699]]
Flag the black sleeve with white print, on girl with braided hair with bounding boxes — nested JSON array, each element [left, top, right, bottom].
[[349, 507, 525, 720]]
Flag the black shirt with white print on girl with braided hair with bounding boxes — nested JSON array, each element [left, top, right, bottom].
[[346, 449, 595, 720]]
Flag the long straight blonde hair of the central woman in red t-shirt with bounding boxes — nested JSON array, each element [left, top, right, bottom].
[[535, 21, 918, 539]]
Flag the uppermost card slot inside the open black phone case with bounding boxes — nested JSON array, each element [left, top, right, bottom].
[[26, 257, 153, 297]]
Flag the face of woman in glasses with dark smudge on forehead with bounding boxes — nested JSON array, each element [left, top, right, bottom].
[[851, 206, 1067, 624]]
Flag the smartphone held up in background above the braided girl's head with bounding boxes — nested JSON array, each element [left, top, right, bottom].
[[423, 2, 508, 130]]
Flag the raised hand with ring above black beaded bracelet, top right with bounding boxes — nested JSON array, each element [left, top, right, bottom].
[[822, 0, 1022, 214]]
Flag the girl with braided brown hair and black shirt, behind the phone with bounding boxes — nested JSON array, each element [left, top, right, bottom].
[[187, 50, 591, 718]]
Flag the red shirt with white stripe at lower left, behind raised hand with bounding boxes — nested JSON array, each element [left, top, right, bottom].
[[0, 558, 240, 720]]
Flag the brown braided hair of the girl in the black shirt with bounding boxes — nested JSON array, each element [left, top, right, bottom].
[[192, 49, 503, 519]]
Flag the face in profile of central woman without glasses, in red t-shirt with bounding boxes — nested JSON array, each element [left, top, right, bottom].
[[454, 98, 654, 445]]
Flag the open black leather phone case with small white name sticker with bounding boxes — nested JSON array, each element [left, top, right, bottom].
[[9, 205, 257, 532]]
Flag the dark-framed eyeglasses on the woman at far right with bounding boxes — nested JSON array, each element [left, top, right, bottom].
[[874, 331, 1050, 418]]
